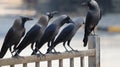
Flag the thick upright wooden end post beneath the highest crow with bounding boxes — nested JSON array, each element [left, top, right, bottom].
[[88, 35, 100, 67]]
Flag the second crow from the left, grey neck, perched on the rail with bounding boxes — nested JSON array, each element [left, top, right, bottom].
[[15, 13, 57, 56]]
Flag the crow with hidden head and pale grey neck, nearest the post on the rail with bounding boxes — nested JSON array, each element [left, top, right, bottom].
[[47, 17, 84, 53]]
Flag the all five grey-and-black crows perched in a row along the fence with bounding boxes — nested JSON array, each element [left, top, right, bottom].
[[0, 0, 101, 58]]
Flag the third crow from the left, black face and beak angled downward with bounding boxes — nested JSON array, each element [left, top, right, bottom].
[[32, 15, 72, 55]]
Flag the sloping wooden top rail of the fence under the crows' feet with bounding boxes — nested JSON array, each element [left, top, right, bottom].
[[0, 49, 95, 66]]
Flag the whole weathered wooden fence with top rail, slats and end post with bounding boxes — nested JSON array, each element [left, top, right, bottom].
[[0, 36, 100, 67]]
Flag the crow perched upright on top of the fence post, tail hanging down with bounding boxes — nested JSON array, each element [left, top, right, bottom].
[[83, 0, 101, 47]]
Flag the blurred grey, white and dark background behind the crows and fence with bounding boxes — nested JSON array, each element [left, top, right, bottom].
[[0, 0, 120, 67]]
